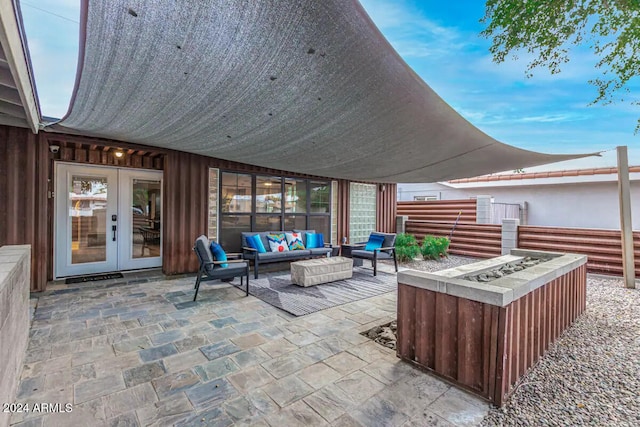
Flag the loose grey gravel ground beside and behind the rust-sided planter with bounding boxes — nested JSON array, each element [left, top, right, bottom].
[[402, 256, 640, 426]]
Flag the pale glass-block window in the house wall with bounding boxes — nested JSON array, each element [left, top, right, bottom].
[[349, 182, 376, 243]]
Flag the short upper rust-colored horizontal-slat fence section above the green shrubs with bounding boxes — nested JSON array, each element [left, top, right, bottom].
[[398, 199, 477, 224]]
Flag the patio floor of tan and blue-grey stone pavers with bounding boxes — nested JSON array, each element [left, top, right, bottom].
[[11, 271, 489, 427]]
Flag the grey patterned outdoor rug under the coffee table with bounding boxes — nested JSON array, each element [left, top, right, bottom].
[[249, 268, 398, 316]]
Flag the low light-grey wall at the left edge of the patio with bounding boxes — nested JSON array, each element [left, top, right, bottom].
[[0, 245, 31, 427]]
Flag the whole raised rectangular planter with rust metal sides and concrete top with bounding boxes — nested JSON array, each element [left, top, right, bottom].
[[397, 249, 587, 406]]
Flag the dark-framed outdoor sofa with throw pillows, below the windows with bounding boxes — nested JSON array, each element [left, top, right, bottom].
[[242, 230, 333, 279]]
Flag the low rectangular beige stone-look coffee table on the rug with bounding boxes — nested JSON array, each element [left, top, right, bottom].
[[291, 256, 353, 287]]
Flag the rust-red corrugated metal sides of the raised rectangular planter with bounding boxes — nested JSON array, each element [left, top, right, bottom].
[[397, 265, 587, 406]]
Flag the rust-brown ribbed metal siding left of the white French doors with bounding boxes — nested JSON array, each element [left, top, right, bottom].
[[0, 126, 51, 291]]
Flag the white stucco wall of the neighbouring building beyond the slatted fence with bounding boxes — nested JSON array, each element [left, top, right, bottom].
[[398, 181, 640, 230]]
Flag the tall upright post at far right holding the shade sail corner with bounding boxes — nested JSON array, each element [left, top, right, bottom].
[[616, 146, 636, 289]]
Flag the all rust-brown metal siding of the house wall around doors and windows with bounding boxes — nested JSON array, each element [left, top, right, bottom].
[[0, 126, 396, 291]]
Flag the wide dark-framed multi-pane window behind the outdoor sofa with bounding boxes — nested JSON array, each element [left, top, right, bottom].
[[216, 169, 335, 252]]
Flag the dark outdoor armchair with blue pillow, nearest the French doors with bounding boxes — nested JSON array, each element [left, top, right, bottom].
[[193, 235, 249, 301]]
